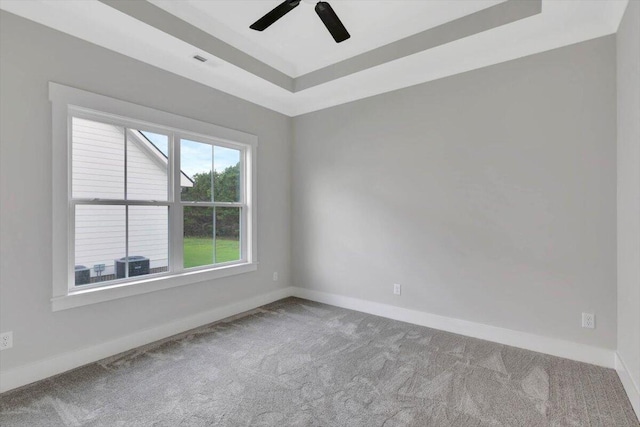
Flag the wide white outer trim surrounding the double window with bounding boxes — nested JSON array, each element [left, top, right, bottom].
[[49, 82, 258, 311]]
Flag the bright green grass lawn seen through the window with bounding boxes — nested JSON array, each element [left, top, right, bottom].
[[184, 237, 240, 268]]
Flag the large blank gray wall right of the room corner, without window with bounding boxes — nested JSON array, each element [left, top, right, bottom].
[[292, 36, 616, 349]]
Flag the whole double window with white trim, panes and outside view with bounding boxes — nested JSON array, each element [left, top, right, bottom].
[[50, 83, 257, 310]]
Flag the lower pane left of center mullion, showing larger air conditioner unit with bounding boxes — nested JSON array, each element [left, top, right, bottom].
[[129, 206, 169, 277]]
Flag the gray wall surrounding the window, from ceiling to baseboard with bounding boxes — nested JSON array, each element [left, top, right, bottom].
[[0, 12, 292, 371]]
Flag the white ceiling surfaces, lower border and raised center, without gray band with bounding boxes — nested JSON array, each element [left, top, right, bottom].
[[0, 0, 628, 116]]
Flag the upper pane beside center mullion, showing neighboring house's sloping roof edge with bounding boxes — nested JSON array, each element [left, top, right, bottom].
[[127, 129, 169, 201]]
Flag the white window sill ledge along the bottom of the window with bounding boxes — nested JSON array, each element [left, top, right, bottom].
[[51, 262, 258, 311]]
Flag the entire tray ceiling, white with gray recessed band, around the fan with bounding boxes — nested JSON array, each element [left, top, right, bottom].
[[0, 0, 627, 116]]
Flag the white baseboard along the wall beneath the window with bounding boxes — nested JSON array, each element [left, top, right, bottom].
[[0, 288, 293, 393]]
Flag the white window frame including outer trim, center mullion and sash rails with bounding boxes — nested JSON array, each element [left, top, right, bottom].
[[49, 82, 258, 311]]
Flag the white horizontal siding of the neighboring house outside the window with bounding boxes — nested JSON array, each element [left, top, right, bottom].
[[72, 118, 168, 276]]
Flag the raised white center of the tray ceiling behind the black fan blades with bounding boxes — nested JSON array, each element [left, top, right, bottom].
[[150, 0, 505, 77]]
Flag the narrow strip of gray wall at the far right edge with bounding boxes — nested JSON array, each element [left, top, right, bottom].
[[616, 1, 640, 394]]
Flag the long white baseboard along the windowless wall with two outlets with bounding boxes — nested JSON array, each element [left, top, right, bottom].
[[293, 287, 615, 368]]
